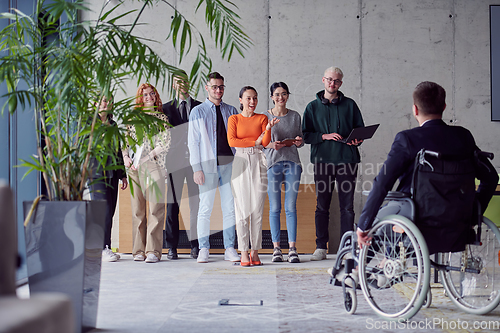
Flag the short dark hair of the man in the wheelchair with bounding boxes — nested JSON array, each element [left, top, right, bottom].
[[413, 81, 446, 115]]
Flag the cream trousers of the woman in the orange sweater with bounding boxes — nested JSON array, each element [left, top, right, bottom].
[[231, 147, 267, 251]]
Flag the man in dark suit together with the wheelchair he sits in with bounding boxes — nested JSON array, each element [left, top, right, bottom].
[[329, 82, 500, 320]]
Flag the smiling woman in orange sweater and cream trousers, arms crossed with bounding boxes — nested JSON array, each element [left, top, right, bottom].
[[227, 86, 279, 266]]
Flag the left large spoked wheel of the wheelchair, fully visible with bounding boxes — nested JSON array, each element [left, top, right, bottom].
[[359, 215, 430, 320]]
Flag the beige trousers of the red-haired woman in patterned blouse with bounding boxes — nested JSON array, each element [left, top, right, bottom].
[[128, 161, 165, 259]]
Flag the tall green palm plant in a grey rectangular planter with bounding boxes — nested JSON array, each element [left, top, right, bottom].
[[0, 0, 251, 331]]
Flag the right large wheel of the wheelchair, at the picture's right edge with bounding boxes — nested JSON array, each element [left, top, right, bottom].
[[438, 218, 500, 314]]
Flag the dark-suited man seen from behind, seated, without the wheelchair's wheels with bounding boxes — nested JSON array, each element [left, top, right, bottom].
[[357, 81, 498, 254]]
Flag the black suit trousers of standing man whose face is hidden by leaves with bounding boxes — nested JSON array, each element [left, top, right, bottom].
[[165, 167, 200, 249]]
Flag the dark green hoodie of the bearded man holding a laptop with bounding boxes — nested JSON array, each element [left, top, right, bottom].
[[302, 90, 365, 164]]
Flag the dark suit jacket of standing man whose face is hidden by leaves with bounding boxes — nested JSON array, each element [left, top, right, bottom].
[[163, 97, 201, 172]]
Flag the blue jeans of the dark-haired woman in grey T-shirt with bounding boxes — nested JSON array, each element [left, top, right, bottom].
[[267, 161, 302, 242]]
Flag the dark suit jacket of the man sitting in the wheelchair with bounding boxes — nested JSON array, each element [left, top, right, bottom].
[[358, 119, 498, 231]]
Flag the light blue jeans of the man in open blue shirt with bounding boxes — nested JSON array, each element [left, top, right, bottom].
[[197, 163, 236, 249]]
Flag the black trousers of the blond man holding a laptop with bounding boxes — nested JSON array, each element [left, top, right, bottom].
[[314, 163, 358, 249]]
